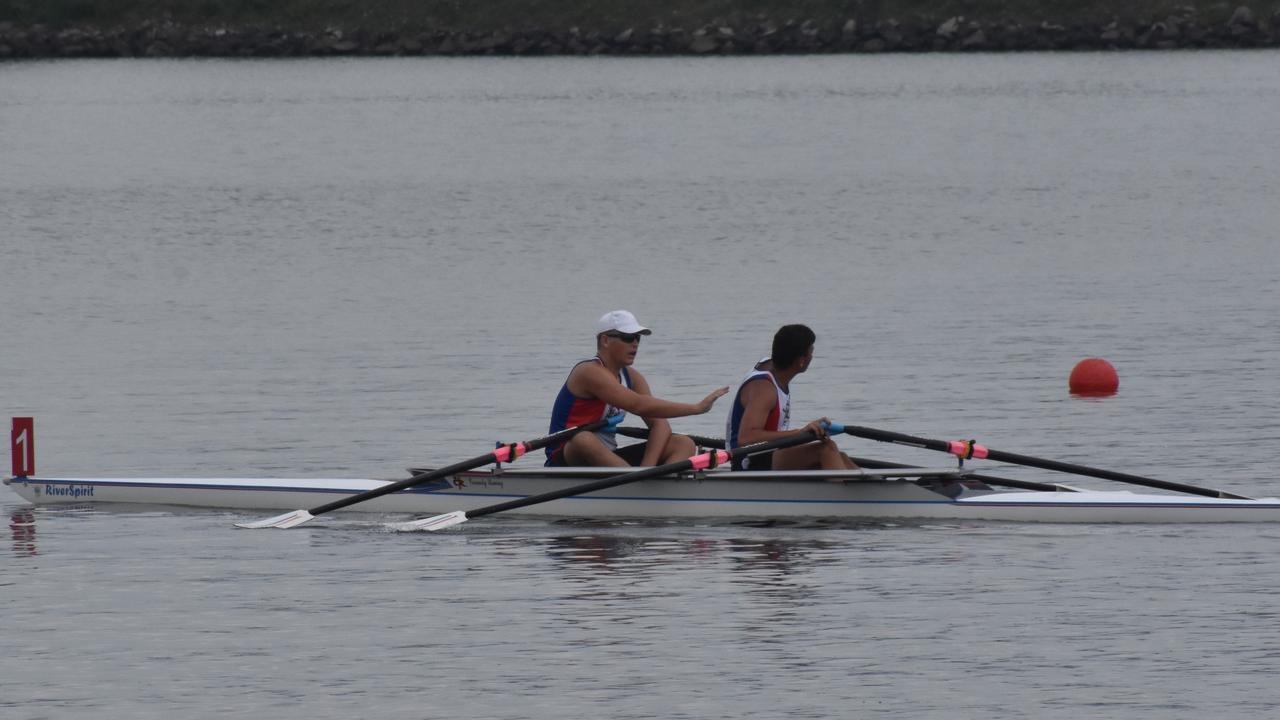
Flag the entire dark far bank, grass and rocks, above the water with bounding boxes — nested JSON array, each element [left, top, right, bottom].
[[0, 0, 1280, 59]]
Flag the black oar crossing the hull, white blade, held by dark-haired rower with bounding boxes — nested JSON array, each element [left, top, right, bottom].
[[387, 425, 817, 532]]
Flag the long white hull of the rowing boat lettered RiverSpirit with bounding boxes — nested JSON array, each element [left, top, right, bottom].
[[5, 471, 1280, 523]]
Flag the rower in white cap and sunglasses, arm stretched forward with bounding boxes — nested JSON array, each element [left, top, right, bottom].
[[547, 310, 728, 466]]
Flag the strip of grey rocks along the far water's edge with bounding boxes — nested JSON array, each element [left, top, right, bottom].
[[0, 6, 1280, 59]]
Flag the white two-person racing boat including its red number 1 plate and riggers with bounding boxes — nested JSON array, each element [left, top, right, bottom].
[[5, 419, 1280, 520]]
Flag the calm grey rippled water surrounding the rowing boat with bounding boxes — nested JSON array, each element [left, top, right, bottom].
[[0, 53, 1280, 720]]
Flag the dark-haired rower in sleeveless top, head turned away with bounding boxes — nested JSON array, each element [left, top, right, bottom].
[[724, 324, 858, 470]]
